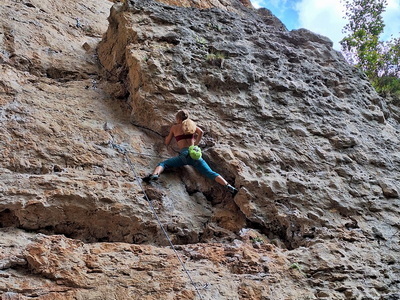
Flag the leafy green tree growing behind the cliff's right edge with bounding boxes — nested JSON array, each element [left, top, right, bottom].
[[340, 0, 400, 94]]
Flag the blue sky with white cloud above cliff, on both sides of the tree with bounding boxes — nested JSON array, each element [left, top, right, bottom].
[[251, 0, 400, 50]]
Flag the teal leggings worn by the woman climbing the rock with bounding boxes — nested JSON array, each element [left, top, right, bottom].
[[158, 148, 219, 180]]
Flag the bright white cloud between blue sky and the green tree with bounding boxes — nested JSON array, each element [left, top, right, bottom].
[[295, 0, 347, 50]]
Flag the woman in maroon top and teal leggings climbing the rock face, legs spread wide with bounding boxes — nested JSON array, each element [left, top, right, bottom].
[[143, 110, 237, 195]]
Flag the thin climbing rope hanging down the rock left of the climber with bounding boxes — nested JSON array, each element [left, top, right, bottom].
[[111, 142, 203, 299]]
